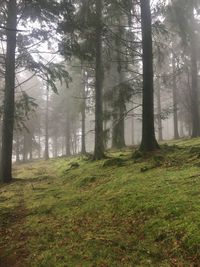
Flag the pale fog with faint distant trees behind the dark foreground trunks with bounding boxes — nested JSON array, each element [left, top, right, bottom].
[[0, 1, 200, 162]]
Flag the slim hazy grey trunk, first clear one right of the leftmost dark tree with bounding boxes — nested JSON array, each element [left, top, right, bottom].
[[44, 87, 49, 160]]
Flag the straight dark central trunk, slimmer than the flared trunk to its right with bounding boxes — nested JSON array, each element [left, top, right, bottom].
[[94, 0, 104, 160]]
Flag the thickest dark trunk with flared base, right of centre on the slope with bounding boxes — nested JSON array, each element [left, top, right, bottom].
[[140, 0, 159, 152]]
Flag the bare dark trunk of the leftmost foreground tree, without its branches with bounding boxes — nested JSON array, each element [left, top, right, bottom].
[[0, 0, 17, 183]]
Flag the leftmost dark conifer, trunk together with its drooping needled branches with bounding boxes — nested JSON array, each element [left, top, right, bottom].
[[0, 0, 70, 182]]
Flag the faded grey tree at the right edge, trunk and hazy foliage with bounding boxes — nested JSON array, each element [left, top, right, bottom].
[[168, 0, 200, 137]]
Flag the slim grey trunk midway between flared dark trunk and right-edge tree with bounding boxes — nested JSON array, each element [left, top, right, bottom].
[[172, 53, 179, 139]]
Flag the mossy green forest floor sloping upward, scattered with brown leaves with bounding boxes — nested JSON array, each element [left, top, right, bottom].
[[0, 139, 200, 267]]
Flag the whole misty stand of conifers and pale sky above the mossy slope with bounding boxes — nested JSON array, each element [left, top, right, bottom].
[[0, 0, 200, 184]]
